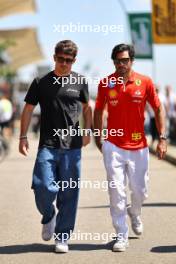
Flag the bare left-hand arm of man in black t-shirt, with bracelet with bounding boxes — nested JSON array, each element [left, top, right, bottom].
[[19, 103, 35, 156]]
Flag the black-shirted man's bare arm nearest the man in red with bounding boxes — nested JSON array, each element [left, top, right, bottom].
[[82, 103, 92, 147]]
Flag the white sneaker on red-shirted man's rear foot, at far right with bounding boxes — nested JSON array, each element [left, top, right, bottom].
[[127, 207, 143, 236]]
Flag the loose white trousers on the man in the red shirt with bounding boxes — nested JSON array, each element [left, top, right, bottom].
[[102, 141, 149, 238]]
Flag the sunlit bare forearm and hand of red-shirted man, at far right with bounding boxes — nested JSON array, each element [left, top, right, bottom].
[[155, 104, 167, 159]]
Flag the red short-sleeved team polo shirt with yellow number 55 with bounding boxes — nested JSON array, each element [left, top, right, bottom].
[[95, 72, 160, 150]]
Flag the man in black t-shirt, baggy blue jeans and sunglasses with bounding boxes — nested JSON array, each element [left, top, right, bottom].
[[19, 40, 92, 252]]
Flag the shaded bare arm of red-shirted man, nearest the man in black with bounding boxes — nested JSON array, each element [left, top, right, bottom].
[[94, 109, 103, 152]]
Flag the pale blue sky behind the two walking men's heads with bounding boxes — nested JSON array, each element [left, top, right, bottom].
[[0, 0, 176, 95]]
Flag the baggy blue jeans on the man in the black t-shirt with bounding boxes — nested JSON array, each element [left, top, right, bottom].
[[32, 147, 81, 239]]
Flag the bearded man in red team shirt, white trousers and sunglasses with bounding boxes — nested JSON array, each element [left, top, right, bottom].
[[94, 44, 167, 251]]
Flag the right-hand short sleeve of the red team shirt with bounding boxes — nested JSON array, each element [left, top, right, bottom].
[[147, 79, 161, 111]]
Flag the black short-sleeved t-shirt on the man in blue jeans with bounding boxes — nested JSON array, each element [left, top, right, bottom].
[[24, 71, 89, 149]]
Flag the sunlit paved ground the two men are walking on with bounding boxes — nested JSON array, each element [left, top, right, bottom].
[[0, 137, 176, 264]]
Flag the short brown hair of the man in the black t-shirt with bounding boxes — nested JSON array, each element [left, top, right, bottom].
[[55, 40, 78, 57]]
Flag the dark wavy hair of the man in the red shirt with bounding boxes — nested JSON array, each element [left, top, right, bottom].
[[111, 44, 135, 61]]
